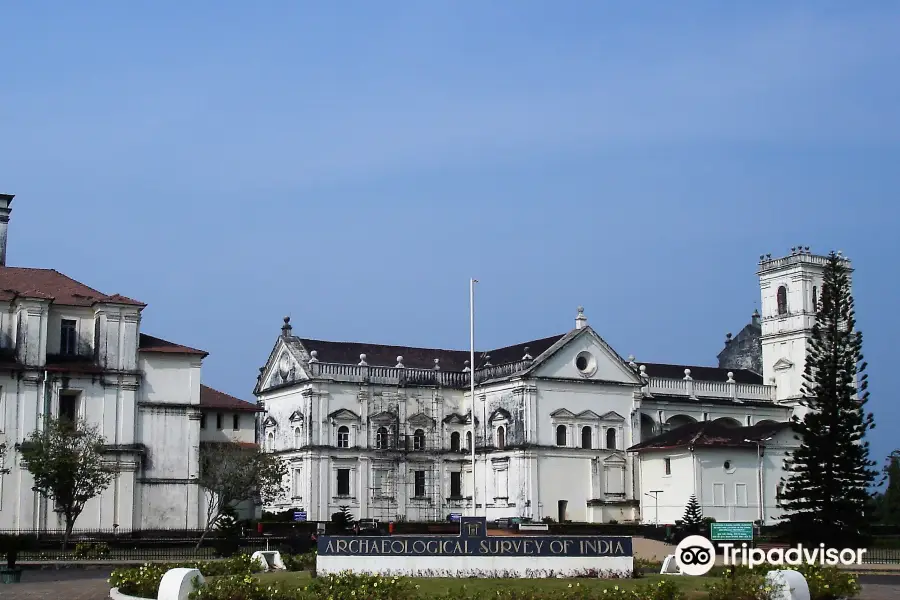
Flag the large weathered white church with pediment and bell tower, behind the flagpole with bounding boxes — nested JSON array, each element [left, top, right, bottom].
[[254, 248, 849, 523]]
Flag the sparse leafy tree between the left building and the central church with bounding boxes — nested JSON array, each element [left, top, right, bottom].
[[197, 442, 287, 548]]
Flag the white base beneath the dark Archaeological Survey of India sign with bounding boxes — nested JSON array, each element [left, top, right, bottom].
[[316, 555, 634, 579]]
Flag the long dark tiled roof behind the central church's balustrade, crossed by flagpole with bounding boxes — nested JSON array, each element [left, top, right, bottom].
[[295, 334, 563, 371]]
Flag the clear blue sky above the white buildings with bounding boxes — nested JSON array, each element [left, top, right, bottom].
[[0, 0, 900, 474]]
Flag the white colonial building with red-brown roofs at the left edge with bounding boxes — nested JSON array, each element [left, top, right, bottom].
[[0, 195, 250, 530]]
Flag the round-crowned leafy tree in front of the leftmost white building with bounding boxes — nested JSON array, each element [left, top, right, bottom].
[[19, 417, 116, 550]]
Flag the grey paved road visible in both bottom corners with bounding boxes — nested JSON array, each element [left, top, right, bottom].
[[0, 569, 900, 600]]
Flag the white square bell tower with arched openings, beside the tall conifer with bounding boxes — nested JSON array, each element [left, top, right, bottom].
[[757, 246, 852, 418]]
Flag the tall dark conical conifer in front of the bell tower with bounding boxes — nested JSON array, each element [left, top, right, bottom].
[[782, 252, 877, 547]]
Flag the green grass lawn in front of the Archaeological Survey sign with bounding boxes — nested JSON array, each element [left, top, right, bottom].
[[257, 571, 713, 599]]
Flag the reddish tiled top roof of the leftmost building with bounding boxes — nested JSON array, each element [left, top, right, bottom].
[[0, 267, 147, 307]]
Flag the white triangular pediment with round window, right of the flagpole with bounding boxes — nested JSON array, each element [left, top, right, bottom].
[[527, 327, 643, 387]]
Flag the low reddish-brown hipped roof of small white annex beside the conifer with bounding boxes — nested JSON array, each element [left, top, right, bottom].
[[628, 421, 791, 452]]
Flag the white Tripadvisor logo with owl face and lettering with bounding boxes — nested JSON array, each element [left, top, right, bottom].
[[675, 535, 866, 575]]
